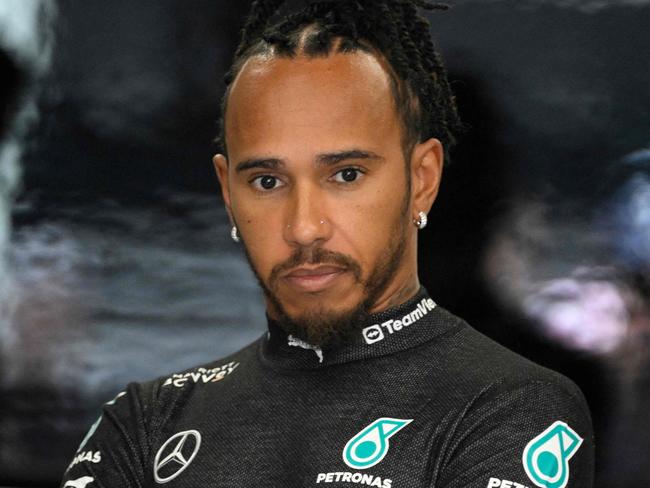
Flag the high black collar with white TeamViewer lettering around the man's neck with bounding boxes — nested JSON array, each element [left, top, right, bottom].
[[260, 286, 460, 369]]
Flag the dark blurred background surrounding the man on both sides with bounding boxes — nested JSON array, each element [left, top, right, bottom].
[[0, 0, 650, 488]]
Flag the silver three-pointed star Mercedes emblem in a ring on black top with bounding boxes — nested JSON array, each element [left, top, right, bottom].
[[153, 430, 201, 483]]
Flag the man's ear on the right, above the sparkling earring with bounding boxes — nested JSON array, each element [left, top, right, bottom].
[[411, 137, 444, 213]]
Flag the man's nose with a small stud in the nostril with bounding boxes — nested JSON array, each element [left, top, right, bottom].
[[284, 181, 332, 247]]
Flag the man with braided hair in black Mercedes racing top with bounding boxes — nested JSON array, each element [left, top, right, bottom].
[[62, 0, 593, 488]]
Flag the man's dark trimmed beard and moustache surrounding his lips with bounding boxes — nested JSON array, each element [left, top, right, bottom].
[[240, 177, 411, 348]]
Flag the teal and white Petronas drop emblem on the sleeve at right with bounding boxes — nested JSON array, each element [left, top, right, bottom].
[[522, 420, 582, 488]]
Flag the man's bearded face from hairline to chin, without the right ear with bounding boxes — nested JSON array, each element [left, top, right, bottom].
[[214, 52, 428, 344]]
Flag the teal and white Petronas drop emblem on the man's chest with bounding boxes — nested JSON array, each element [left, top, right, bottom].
[[343, 417, 413, 469]]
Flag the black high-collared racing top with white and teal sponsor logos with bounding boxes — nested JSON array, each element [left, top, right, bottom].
[[61, 287, 594, 488]]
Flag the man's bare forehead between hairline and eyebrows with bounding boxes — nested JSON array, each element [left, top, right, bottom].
[[225, 51, 399, 156]]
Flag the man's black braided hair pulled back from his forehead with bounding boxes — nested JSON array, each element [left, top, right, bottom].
[[214, 0, 464, 165]]
